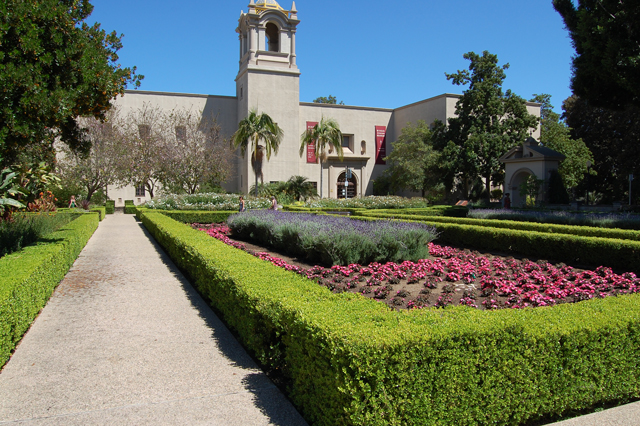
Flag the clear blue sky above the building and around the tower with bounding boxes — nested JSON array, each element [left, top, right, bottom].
[[88, 0, 574, 112]]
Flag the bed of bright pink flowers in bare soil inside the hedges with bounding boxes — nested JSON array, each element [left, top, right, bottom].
[[196, 225, 640, 309]]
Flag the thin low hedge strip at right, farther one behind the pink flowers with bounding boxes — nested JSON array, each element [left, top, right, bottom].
[[355, 210, 640, 241]]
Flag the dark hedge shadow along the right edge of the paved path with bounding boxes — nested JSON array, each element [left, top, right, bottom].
[[136, 219, 307, 426]]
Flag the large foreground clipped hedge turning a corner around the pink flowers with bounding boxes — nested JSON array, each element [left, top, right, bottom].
[[142, 212, 640, 425]]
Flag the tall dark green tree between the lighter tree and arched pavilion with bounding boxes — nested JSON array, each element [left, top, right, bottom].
[[436, 51, 538, 200]]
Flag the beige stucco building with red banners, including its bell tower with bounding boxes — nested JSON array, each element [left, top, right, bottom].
[[108, 0, 540, 206]]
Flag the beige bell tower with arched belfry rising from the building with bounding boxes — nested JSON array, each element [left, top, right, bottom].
[[236, 0, 301, 192]]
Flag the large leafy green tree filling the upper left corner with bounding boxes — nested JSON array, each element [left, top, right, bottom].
[[0, 0, 142, 170]]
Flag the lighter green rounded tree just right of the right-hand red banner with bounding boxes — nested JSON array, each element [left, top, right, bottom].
[[385, 120, 442, 197]]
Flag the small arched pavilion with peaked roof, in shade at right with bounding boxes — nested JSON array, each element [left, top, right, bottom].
[[500, 136, 565, 207]]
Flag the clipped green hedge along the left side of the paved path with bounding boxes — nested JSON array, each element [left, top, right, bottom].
[[0, 213, 99, 366]]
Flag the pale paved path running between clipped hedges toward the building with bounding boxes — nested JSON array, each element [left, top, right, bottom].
[[0, 214, 306, 426]]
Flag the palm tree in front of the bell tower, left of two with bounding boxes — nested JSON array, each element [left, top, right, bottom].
[[231, 109, 284, 197]]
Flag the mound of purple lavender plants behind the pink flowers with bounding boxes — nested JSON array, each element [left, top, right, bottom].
[[227, 210, 436, 265]]
